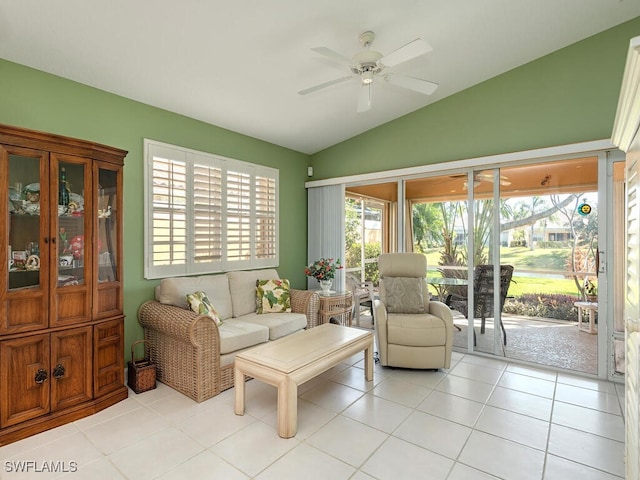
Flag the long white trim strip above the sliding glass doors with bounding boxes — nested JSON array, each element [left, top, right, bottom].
[[304, 139, 616, 188]]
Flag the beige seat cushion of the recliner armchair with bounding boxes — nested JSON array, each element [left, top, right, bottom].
[[387, 313, 447, 347]]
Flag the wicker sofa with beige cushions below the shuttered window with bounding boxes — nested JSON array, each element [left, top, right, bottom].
[[138, 269, 319, 402]]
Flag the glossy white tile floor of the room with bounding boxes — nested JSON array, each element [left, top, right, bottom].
[[0, 353, 624, 480]]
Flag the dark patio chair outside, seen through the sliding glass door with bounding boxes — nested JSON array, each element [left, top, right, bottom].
[[447, 265, 513, 345]]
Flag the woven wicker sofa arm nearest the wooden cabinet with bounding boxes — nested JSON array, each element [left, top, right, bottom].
[[138, 300, 222, 402]]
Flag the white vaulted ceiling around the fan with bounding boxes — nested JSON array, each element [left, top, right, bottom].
[[0, 0, 640, 154]]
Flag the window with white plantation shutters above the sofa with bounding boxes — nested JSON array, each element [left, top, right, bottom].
[[144, 140, 278, 278]]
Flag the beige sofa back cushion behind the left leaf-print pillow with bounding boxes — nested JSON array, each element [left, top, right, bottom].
[[156, 275, 232, 320]]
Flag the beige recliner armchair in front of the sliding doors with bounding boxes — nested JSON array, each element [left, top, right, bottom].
[[373, 253, 454, 368]]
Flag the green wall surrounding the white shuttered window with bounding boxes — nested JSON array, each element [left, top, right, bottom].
[[0, 59, 310, 358]]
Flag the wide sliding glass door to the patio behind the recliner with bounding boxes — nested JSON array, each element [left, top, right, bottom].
[[346, 152, 625, 378]]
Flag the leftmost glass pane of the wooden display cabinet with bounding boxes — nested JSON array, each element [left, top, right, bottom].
[[7, 154, 42, 290]]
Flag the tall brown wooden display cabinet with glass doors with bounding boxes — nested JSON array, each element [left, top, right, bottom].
[[0, 125, 127, 446]]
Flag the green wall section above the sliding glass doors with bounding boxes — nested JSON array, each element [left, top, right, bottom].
[[312, 17, 640, 180]]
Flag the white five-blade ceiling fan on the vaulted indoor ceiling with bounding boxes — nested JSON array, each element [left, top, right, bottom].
[[298, 31, 438, 112]]
